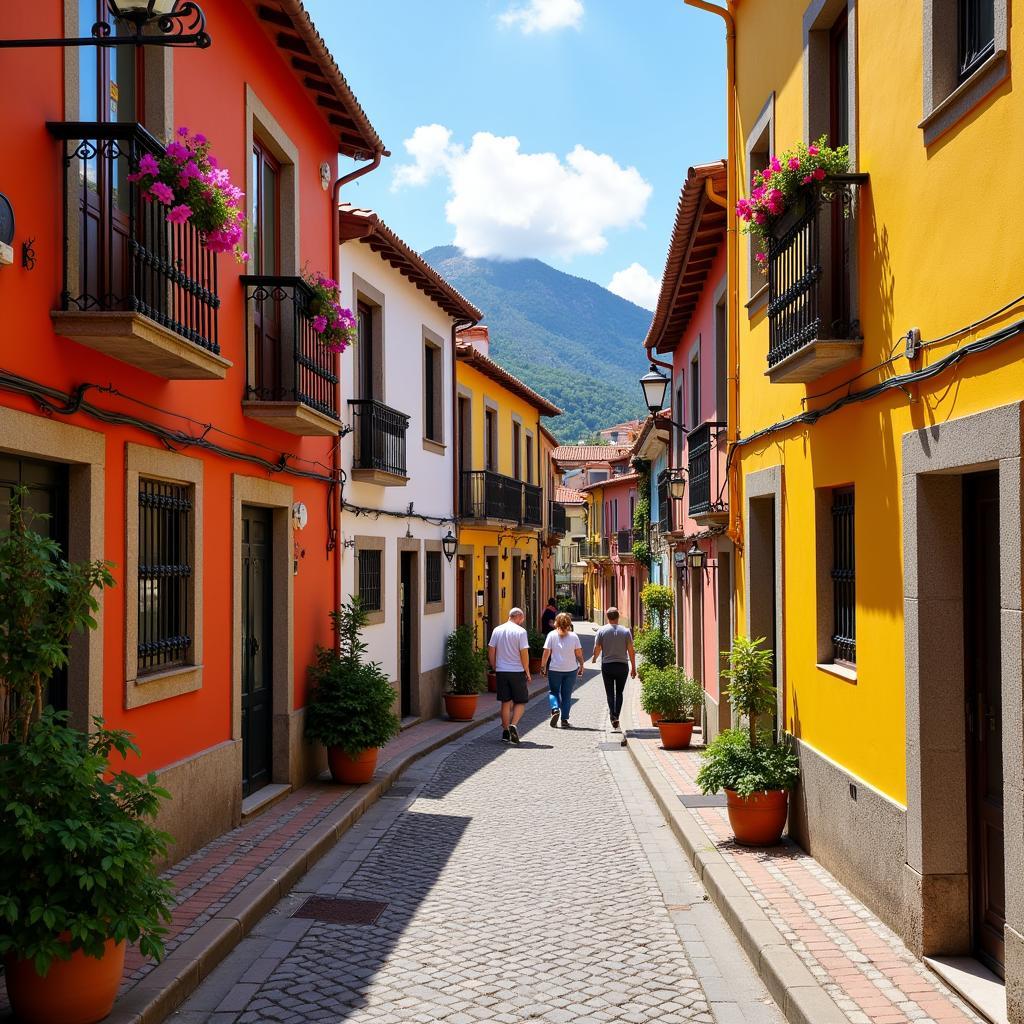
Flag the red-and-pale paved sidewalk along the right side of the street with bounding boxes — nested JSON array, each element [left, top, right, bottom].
[[624, 687, 981, 1024]]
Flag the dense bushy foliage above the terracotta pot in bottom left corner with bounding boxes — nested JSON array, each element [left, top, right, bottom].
[[0, 708, 174, 976]]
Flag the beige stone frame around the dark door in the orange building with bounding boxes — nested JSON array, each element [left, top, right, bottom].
[[231, 473, 296, 790]]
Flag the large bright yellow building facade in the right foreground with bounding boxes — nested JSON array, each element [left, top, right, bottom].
[[720, 0, 1024, 995]]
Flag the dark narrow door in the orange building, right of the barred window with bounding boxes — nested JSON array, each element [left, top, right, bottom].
[[241, 505, 273, 797]]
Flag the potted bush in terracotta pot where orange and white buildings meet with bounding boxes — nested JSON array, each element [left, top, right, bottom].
[[306, 598, 400, 785]]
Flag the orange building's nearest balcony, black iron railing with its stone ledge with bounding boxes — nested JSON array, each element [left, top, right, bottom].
[[47, 122, 230, 380]]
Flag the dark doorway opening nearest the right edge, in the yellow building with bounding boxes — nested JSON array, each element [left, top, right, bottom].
[[964, 471, 1007, 975]]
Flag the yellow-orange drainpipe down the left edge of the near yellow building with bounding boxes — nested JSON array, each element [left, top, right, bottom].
[[683, 0, 742, 547]]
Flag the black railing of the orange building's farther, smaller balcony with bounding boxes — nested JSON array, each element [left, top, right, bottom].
[[242, 274, 341, 420]]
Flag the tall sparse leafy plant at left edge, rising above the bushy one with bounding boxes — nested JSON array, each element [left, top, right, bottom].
[[0, 487, 114, 742]]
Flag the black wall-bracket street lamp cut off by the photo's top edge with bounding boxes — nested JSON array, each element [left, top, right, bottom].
[[0, 0, 212, 49]]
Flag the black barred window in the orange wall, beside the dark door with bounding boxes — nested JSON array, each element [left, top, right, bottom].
[[138, 478, 194, 675]]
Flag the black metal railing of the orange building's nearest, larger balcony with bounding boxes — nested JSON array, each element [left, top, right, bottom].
[[47, 122, 220, 353]]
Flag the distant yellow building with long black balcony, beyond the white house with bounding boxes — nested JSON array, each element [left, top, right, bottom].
[[456, 327, 561, 645]]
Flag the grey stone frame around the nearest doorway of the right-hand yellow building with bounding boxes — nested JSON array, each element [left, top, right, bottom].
[[903, 403, 1024, 978]]
